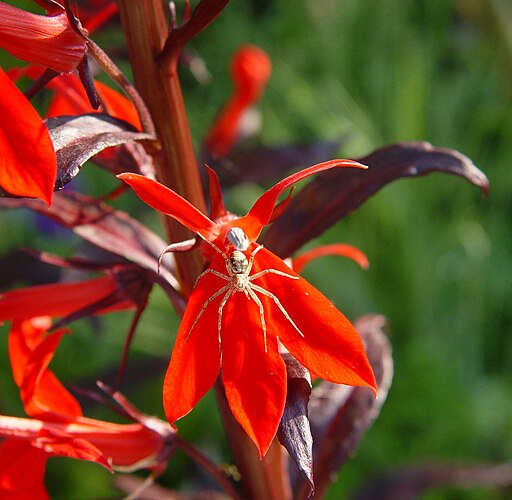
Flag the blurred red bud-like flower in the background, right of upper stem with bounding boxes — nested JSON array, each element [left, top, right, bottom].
[[205, 45, 272, 158]]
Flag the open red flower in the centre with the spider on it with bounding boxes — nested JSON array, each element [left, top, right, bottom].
[[119, 160, 377, 457]]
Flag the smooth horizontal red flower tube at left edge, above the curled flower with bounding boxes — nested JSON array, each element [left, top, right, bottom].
[[0, 276, 121, 321]]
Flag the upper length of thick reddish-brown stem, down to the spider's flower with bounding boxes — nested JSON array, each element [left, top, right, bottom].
[[118, 0, 206, 295]]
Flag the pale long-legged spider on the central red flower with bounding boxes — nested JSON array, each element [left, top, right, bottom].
[[187, 227, 304, 352]]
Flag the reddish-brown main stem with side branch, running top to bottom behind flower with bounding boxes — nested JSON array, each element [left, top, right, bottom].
[[118, 0, 291, 500]]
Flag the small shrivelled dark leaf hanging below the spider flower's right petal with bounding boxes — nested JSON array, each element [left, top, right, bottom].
[[277, 354, 314, 498]]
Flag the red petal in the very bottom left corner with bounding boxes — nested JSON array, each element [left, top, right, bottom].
[[0, 439, 49, 500]]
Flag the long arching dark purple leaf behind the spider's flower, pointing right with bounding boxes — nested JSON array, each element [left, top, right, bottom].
[[265, 142, 489, 258]]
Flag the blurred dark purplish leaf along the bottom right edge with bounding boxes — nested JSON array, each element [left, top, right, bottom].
[[353, 463, 512, 500]]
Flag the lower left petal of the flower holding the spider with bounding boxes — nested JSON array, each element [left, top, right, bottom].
[[164, 255, 227, 424]]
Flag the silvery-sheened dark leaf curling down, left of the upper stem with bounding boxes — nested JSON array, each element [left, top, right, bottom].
[[45, 113, 154, 191]]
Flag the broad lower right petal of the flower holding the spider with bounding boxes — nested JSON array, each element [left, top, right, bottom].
[[253, 249, 377, 392]]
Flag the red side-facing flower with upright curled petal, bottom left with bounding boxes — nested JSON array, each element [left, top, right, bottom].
[[0, 316, 172, 499]]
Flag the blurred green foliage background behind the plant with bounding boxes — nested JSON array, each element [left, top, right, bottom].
[[0, 0, 512, 499]]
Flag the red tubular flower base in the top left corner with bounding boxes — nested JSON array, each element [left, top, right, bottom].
[[0, 0, 86, 73]]
